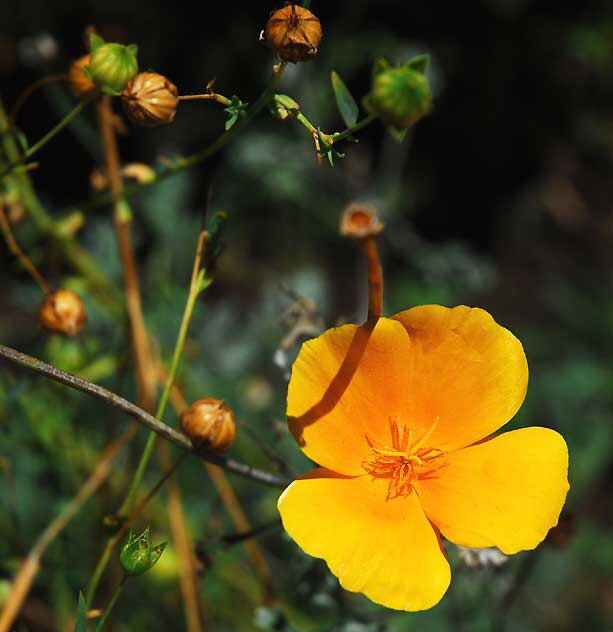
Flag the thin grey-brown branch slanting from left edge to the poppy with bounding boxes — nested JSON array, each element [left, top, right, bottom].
[[0, 345, 291, 489]]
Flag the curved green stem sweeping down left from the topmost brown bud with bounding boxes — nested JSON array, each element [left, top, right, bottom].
[[79, 64, 285, 210]]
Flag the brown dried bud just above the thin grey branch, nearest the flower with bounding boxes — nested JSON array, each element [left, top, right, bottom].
[[179, 397, 236, 452]]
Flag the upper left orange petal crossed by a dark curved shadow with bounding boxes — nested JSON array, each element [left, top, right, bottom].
[[287, 318, 410, 475]]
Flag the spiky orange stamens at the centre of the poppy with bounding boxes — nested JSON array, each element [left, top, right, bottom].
[[362, 417, 445, 501]]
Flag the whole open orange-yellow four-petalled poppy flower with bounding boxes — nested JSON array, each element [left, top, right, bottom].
[[278, 305, 568, 610]]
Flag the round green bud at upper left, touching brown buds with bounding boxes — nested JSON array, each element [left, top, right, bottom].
[[83, 35, 138, 95]]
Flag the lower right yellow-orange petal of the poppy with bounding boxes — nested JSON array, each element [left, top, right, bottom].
[[416, 427, 569, 553]]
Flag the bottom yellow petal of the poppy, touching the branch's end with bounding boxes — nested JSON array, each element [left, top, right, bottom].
[[278, 469, 451, 611]]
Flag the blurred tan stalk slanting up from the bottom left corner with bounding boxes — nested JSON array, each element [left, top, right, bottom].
[[0, 430, 134, 632]]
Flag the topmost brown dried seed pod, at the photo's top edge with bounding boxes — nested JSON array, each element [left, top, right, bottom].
[[260, 4, 322, 64]]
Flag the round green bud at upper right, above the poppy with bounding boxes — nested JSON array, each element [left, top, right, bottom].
[[364, 56, 432, 131]]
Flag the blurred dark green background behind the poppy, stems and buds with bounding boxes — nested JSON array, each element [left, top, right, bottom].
[[0, 0, 613, 632]]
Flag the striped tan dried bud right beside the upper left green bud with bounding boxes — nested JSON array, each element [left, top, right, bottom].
[[121, 72, 179, 127]]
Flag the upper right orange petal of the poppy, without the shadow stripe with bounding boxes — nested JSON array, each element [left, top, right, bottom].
[[394, 305, 528, 450]]
